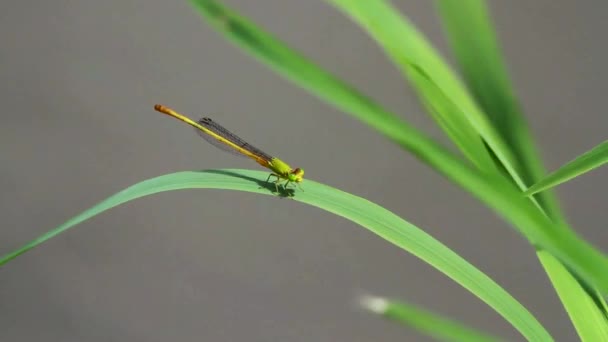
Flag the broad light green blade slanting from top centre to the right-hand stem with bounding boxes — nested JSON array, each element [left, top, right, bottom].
[[327, 0, 525, 189]]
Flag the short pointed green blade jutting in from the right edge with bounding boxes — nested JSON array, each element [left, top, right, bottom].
[[525, 140, 608, 196]]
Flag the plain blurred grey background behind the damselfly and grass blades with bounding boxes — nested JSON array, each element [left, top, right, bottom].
[[0, 0, 608, 341]]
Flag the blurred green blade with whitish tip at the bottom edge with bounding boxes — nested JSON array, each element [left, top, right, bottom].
[[361, 296, 502, 342]]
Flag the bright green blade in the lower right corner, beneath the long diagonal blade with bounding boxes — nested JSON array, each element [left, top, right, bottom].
[[538, 251, 608, 342]]
